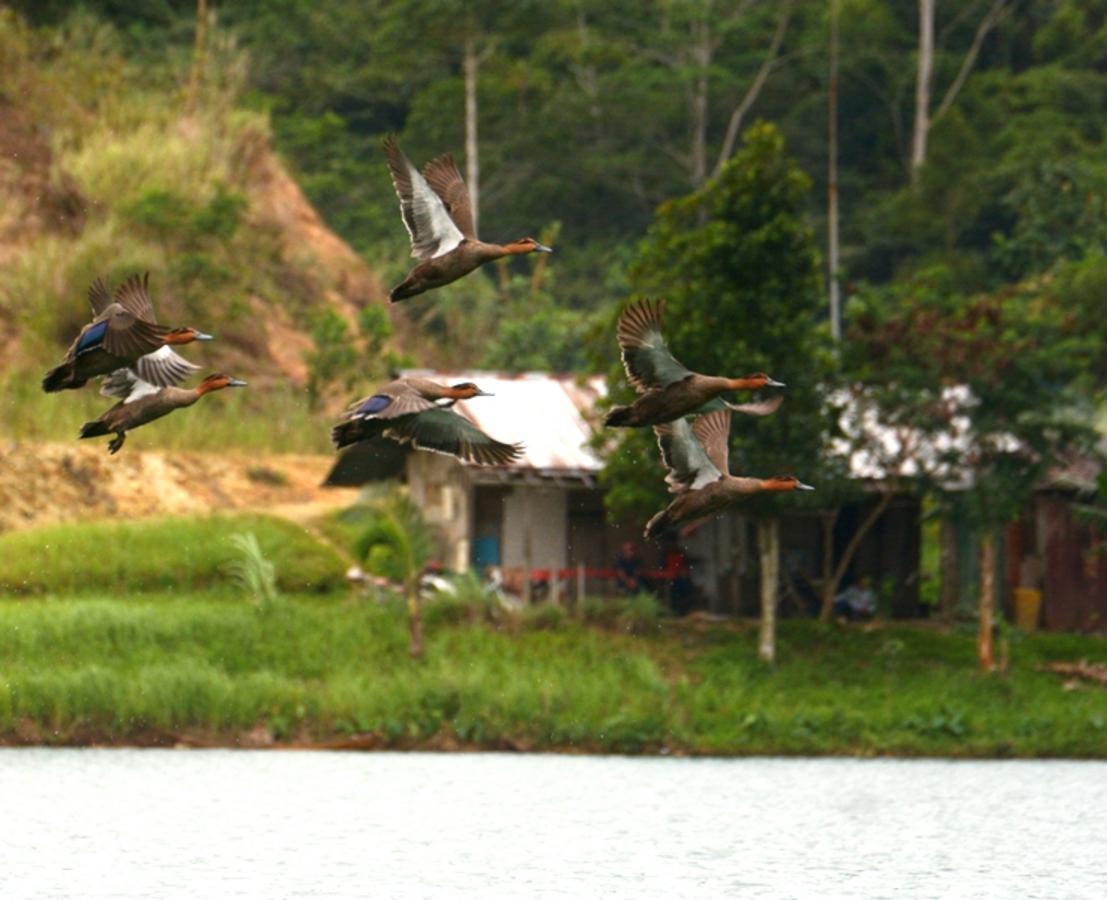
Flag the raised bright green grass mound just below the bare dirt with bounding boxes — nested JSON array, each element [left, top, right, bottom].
[[0, 515, 345, 594]]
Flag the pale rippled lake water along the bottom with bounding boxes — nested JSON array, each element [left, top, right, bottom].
[[0, 749, 1107, 900]]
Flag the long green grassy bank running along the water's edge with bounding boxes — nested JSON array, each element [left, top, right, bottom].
[[0, 591, 1107, 757]]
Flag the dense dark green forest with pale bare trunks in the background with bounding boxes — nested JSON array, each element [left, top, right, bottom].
[[14, 0, 1107, 368]]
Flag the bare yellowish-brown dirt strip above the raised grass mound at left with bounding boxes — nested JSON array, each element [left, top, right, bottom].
[[0, 442, 355, 531]]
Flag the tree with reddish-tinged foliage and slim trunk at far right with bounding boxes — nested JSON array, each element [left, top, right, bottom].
[[847, 267, 1107, 670]]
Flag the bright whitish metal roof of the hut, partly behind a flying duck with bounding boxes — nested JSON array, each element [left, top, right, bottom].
[[403, 369, 607, 476]]
